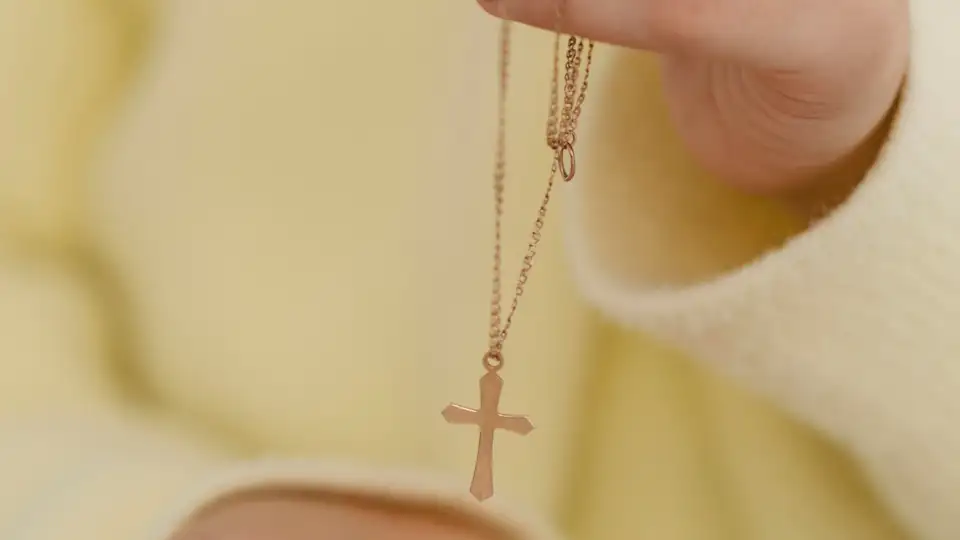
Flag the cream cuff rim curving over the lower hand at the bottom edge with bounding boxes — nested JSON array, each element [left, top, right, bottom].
[[146, 461, 558, 540]]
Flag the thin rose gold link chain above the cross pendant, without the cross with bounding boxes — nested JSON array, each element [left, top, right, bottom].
[[483, 17, 594, 371]]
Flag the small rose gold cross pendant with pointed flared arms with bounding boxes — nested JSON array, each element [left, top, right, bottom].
[[443, 371, 533, 501]]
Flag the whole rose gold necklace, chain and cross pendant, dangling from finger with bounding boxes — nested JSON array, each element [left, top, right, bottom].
[[443, 5, 594, 501]]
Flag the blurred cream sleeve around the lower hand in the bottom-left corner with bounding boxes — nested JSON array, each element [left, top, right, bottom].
[[0, 411, 555, 540]]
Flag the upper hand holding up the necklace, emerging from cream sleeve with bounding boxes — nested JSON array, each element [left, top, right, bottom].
[[479, 0, 909, 196]]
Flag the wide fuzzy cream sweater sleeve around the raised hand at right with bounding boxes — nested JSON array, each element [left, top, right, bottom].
[[568, 0, 960, 540]]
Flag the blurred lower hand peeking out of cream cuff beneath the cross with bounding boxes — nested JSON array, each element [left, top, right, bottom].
[[172, 490, 501, 540]]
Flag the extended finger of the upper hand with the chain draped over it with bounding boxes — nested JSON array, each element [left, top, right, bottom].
[[479, 0, 877, 68]]
